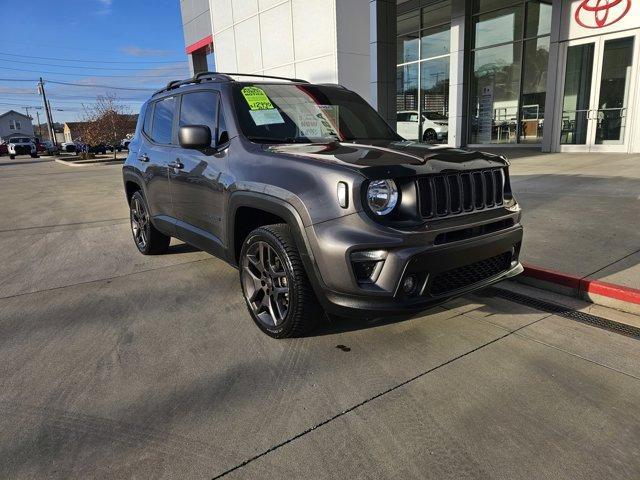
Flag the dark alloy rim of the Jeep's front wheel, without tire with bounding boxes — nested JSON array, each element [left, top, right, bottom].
[[242, 241, 291, 327]]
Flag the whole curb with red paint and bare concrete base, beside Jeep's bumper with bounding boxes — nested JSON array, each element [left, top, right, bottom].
[[516, 264, 640, 314]]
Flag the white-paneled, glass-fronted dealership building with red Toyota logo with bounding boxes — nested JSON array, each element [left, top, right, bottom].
[[180, 0, 640, 152]]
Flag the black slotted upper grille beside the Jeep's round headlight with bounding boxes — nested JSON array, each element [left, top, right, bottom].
[[418, 168, 505, 218]]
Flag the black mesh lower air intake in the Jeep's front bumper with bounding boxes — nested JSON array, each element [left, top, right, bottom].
[[429, 252, 511, 296]]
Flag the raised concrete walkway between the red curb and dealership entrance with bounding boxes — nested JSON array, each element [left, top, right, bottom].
[[504, 150, 640, 289]]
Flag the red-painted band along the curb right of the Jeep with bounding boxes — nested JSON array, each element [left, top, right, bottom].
[[523, 264, 640, 305]]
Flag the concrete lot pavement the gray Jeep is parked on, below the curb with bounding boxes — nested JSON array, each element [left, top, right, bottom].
[[0, 158, 640, 479]]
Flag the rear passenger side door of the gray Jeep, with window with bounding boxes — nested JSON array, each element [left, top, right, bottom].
[[138, 97, 177, 227]]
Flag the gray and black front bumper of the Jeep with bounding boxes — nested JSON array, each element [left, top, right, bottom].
[[307, 209, 523, 317]]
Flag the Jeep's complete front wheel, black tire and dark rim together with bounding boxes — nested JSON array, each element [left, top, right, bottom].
[[238, 223, 324, 338]]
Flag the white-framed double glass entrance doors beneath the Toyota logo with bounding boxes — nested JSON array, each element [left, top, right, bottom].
[[557, 33, 638, 152]]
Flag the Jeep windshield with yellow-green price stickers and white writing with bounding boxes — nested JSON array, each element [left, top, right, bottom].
[[234, 83, 399, 143]]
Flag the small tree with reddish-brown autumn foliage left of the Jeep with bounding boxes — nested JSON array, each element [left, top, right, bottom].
[[80, 93, 136, 159]]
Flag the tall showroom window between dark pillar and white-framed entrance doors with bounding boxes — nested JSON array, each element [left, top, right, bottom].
[[469, 0, 552, 144]]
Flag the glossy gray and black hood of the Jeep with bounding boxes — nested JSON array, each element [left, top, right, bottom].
[[264, 141, 508, 178]]
